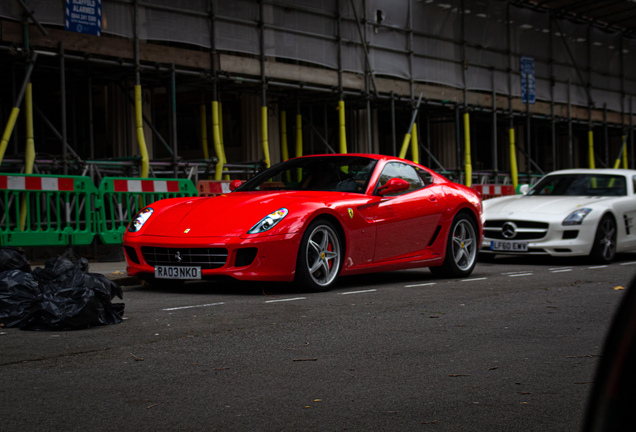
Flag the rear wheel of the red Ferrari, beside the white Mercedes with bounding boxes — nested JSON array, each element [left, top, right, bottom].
[[430, 213, 479, 278]]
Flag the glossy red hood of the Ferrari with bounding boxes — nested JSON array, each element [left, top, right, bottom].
[[144, 192, 320, 237]]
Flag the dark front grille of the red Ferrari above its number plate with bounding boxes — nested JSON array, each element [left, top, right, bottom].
[[141, 246, 227, 270]]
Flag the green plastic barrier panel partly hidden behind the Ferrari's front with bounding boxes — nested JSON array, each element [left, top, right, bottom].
[[98, 177, 198, 244]]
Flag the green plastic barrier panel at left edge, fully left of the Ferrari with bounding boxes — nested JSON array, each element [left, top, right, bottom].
[[0, 173, 98, 246]]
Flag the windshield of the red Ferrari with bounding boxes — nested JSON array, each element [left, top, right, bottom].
[[236, 155, 377, 193]]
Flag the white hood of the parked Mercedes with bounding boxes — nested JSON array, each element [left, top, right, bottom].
[[484, 195, 616, 217]]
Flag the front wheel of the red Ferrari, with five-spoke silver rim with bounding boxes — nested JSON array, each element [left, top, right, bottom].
[[295, 219, 344, 292]]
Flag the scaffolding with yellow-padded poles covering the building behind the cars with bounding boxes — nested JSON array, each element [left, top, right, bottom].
[[0, 0, 636, 184]]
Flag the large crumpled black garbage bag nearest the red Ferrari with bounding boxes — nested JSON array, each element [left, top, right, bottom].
[[0, 257, 124, 330]]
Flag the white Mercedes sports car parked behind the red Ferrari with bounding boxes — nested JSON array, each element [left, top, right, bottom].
[[480, 169, 636, 264]]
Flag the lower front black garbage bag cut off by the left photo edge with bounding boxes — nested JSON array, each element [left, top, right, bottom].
[[0, 268, 42, 328]]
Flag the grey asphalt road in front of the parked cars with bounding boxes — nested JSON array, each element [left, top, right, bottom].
[[0, 255, 636, 431]]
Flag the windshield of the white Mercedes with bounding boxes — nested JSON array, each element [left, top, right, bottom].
[[528, 174, 627, 196]]
